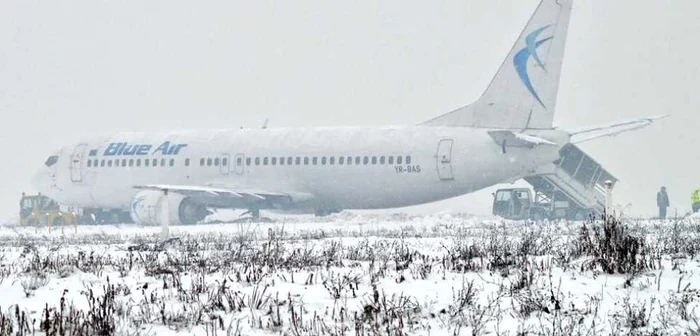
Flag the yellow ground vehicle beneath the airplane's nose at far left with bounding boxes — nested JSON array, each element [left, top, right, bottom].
[[19, 193, 78, 226]]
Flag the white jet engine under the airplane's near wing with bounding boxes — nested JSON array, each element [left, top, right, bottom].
[[129, 190, 211, 225]]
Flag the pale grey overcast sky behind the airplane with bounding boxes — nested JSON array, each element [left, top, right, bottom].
[[0, 0, 700, 221]]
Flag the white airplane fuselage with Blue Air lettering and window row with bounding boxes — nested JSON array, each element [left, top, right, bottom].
[[34, 126, 559, 211]]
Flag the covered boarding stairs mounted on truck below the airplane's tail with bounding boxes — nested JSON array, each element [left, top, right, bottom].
[[524, 144, 618, 220]]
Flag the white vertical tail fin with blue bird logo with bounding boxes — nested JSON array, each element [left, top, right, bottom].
[[422, 0, 573, 129]]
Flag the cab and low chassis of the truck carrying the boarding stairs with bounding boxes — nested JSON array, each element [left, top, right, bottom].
[[492, 188, 592, 220]]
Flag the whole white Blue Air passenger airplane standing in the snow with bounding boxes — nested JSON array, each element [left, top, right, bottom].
[[32, 0, 660, 225]]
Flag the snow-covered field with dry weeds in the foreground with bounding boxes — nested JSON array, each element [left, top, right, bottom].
[[0, 213, 700, 336]]
